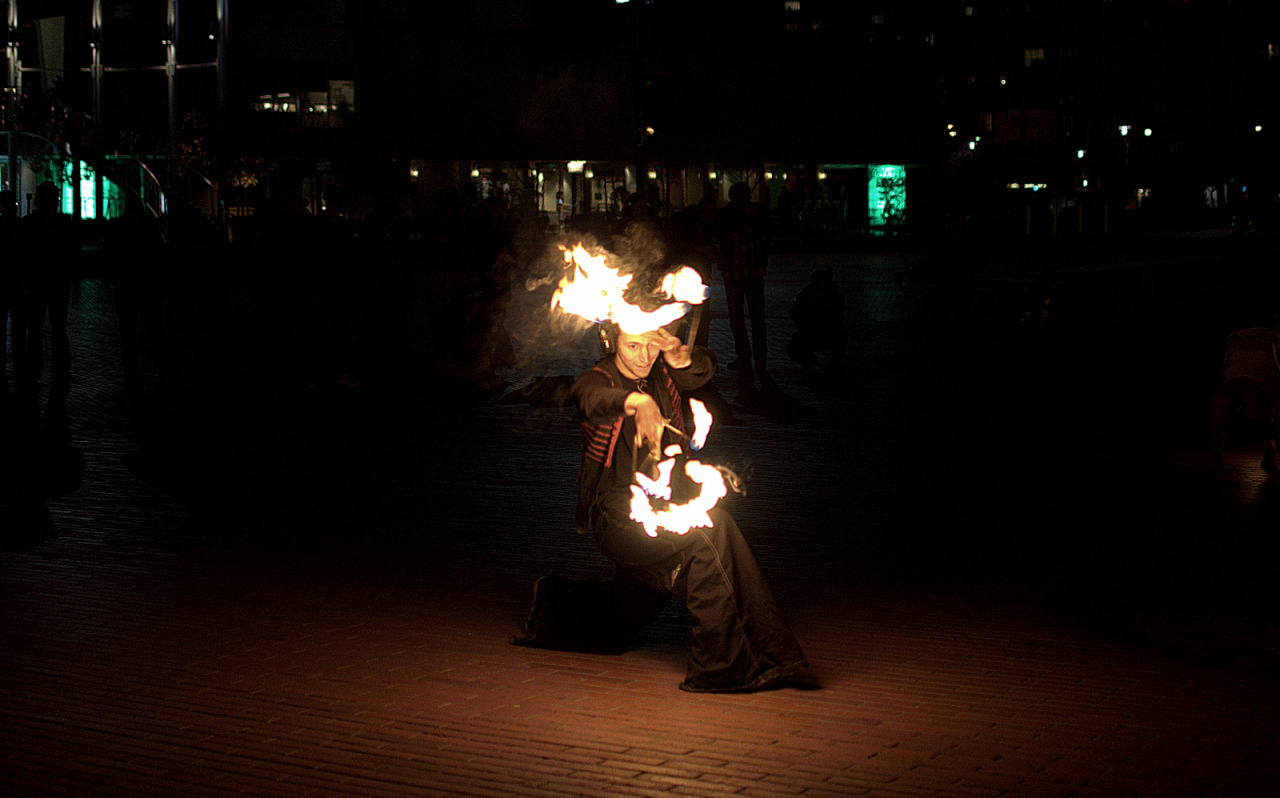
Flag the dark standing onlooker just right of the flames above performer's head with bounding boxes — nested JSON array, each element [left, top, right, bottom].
[[713, 183, 772, 383]]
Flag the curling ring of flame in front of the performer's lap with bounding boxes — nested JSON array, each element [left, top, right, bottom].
[[631, 398, 728, 538]]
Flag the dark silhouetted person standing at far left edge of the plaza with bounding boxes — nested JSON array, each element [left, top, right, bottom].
[[18, 181, 79, 402]]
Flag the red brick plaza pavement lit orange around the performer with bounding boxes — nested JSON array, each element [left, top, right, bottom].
[[0, 234, 1280, 797]]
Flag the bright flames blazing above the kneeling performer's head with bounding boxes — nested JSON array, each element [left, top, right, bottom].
[[552, 243, 709, 336]]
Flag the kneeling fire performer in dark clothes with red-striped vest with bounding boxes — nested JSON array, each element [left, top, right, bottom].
[[517, 323, 808, 692]]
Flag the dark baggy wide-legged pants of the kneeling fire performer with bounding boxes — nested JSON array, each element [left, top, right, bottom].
[[514, 509, 808, 692]]
